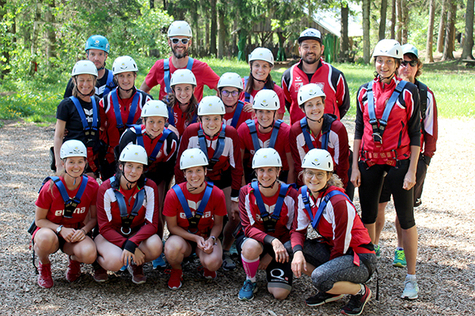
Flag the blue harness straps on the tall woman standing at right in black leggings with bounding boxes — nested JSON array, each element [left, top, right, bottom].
[[367, 80, 407, 144]]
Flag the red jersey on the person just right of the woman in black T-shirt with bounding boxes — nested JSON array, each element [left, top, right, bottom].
[[99, 89, 152, 163]]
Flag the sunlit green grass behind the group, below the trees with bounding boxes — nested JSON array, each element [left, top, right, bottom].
[[0, 58, 475, 123]]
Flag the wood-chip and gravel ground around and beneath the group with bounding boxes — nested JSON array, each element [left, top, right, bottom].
[[0, 119, 475, 315]]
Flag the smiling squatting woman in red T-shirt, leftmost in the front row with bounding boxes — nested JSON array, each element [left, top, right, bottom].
[[33, 140, 99, 288]]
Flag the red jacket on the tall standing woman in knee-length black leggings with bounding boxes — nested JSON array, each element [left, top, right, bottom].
[[355, 77, 421, 164]]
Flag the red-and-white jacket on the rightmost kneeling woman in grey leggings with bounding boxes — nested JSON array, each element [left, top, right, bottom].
[[291, 186, 374, 260]]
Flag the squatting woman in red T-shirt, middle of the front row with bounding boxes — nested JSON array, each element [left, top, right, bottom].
[[163, 148, 227, 290]]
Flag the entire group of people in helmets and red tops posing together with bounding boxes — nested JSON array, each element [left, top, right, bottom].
[[32, 21, 437, 315]]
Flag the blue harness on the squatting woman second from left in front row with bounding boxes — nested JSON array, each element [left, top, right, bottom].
[[110, 176, 146, 236]]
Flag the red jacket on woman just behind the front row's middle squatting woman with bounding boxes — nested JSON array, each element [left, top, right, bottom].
[[175, 123, 243, 197]]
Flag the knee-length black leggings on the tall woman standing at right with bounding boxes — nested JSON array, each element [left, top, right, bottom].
[[358, 159, 416, 229]]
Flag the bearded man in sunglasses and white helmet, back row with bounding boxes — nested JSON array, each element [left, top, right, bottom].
[[140, 21, 219, 102]]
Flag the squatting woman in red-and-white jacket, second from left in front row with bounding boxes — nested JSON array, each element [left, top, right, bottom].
[[94, 144, 163, 284]]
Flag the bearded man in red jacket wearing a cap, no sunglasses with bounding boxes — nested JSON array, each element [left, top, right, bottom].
[[282, 28, 350, 124]]
